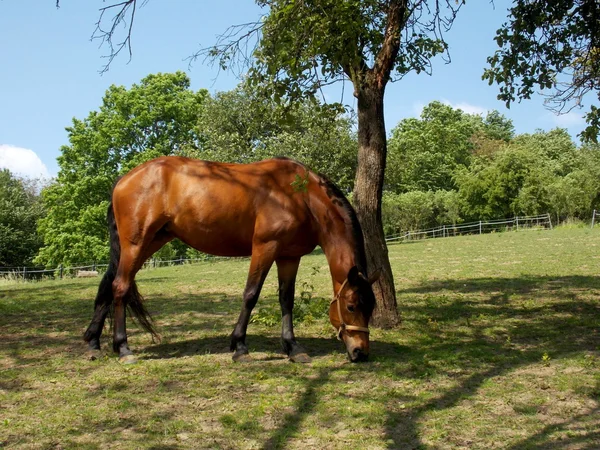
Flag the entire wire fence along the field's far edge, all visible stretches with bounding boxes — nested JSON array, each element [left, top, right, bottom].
[[0, 211, 552, 280]]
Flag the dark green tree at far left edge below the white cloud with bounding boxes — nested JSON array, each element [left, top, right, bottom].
[[0, 169, 44, 267]]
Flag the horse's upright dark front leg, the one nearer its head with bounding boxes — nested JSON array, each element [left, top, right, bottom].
[[277, 258, 311, 363]]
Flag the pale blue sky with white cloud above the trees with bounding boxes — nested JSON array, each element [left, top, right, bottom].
[[0, 0, 585, 177]]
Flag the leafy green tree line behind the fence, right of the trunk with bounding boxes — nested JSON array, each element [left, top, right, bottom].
[[383, 102, 600, 234]]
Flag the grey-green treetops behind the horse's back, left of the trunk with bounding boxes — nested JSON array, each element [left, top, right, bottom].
[[196, 83, 357, 192]]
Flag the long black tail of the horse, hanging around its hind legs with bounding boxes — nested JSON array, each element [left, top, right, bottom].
[[83, 201, 160, 342]]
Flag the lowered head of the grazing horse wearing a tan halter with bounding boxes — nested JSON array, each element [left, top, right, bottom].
[[329, 266, 379, 362]]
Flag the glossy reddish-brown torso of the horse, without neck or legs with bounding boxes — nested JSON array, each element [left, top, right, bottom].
[[113, 157, 314, 256]]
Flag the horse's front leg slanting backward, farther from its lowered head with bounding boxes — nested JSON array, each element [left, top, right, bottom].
[[231, 243, 276, 362]]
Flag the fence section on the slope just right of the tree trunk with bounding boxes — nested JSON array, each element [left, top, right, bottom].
[[385, 214, 552, 243]]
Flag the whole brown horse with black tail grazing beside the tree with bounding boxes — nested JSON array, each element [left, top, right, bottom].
[[84, 157, 376, 362]]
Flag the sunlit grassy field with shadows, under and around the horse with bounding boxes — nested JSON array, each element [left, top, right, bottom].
[[0, 229, 600, 449]]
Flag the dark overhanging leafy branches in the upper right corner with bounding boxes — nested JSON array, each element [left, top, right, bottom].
[[483, 0, 600, 142]]
